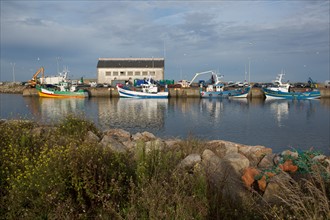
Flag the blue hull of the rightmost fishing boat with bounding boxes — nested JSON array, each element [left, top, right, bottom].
[[263, 89, 321, 100]]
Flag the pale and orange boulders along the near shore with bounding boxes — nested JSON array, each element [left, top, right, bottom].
[[26, 121, 330, 204]]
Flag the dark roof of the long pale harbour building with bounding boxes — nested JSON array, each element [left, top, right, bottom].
[[97, 58, 165, 68]]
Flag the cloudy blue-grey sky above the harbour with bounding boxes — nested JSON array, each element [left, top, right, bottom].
[[0, 0, 330, 82]]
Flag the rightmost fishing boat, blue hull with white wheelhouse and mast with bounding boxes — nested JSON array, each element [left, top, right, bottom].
[[263, 72, 321, 100]]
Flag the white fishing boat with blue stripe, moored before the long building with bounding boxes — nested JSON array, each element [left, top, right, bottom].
[[116, 78, 168, 99]]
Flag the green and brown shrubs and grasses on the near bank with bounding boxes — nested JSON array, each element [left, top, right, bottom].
[[0, 116, 330, 219]]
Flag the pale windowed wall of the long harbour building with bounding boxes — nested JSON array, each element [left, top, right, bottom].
[[97, 68, 164, 84]]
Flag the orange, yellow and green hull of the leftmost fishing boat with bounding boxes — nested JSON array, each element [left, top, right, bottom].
[[37, 87, 88, 98]]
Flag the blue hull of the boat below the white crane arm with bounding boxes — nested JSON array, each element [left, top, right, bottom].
[[200, 87, 250, 98]]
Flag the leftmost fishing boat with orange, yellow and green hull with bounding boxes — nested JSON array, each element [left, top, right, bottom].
[[36, 82, 89, 98]]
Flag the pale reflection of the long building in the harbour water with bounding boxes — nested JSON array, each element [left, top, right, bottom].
[[94, 98, 168, 133]]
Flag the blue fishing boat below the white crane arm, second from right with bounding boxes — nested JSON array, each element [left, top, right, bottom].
[[200, 83, 251, 98]]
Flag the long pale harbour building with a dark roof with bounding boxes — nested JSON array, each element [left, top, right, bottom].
[[97, 58, 165, 84]]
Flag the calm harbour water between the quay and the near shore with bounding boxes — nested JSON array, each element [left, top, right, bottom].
[[0, 94, 330, 155]]
